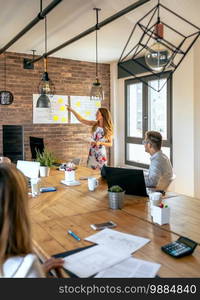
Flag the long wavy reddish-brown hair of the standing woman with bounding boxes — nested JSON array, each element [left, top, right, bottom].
[[92, 107, 113, 140]]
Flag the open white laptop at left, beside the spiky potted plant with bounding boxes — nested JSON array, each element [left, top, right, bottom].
[[17, 160, 40, 178]]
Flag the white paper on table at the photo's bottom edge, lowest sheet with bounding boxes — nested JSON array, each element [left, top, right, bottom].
[[95, 257, 161, 278]]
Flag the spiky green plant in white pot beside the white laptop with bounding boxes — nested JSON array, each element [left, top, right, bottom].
[[36, 149, 55, 177]]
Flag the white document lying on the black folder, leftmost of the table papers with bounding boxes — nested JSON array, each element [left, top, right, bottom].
[[64, 245, 130, 277]]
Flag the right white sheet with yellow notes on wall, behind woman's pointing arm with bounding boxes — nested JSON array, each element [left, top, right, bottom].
[[70, 96, 101, 123]]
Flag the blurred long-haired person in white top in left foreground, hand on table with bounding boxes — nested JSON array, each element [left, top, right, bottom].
[[0, 163, 63, 278]]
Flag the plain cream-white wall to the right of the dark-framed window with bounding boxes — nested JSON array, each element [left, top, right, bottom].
[[173, 50, 194, 196]]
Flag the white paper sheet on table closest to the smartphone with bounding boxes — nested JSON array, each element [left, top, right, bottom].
[[85, 228, 150, 254]]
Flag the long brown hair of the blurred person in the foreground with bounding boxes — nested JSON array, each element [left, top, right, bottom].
[[0, 164, 32, 269]]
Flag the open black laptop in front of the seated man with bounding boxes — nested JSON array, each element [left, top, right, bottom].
[[101, 166, 147, 196]]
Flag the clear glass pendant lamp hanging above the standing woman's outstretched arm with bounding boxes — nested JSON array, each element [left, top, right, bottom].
[[90, 8, 104, 101]]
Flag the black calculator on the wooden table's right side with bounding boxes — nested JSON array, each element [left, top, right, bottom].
[[161, 236, 198, 258]]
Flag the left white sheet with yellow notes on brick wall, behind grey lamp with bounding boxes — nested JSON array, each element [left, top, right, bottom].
[[33, 94, 69, 124]]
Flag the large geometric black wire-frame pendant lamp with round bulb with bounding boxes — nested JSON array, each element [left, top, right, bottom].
[[118, 0, 200, 92]]
